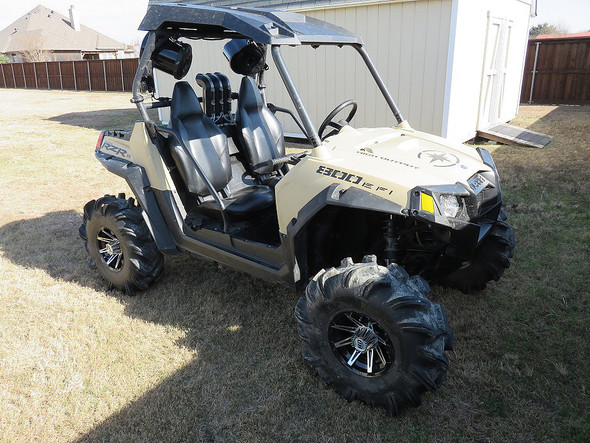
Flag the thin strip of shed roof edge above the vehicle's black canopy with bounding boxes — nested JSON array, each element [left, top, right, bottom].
[[149, 0, 386, 11]]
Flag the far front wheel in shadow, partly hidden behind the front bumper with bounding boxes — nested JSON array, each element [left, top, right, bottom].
[[442, 210, 516, 293]]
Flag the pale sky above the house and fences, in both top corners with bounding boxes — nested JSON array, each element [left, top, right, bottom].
[[0, 0, 590, 43]]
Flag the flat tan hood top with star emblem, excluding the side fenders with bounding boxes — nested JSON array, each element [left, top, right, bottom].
[[326, 126, 492, 190]]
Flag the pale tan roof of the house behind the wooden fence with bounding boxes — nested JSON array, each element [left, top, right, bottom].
[[0, 5, 125, 53]]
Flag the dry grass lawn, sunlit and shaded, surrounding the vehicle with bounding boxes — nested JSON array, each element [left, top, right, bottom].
[[0, 90, 590, 442]]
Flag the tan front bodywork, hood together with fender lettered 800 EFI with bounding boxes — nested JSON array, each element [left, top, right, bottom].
[[275, 126, 497, 234]]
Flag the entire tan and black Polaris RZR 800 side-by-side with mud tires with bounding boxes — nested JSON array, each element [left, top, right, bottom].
[[80, 4, 515, 414]]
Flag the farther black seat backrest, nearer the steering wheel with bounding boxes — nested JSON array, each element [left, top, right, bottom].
[[236, 76, 285, 175]]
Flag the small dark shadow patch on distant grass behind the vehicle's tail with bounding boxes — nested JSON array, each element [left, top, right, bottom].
[[47, 108, 158, 130]]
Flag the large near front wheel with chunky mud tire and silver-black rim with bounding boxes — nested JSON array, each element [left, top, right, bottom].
[[295, 256, 453, 415]]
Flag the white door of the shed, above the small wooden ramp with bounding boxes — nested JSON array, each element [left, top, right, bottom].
[[477, 15, 512, 129]]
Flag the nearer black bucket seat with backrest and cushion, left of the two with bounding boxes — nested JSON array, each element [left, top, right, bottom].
[[170, 82, 274, 218]]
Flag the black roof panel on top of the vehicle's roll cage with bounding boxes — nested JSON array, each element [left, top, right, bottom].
[[139, 3, 362, 45]]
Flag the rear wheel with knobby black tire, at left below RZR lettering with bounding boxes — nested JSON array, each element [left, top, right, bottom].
[[80, 195, 164, 295]]
